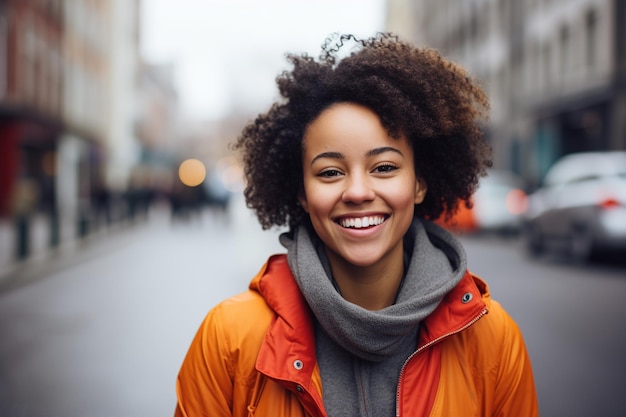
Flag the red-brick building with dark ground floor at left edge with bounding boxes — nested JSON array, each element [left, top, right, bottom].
[[0, 0, 64, 216]]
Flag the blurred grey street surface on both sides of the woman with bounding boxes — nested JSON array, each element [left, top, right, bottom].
[[0, 196, 626, 417]]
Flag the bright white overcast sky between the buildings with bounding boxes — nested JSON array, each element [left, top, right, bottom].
[[141, 0, 385, 119]]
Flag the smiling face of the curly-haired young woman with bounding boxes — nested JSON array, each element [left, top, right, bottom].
[[300, 103, 426, 267]]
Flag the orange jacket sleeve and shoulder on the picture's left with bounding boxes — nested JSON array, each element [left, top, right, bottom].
[[175, 291, 272, 417]]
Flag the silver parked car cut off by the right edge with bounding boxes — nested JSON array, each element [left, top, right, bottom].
[[524, 151, 626, 261]]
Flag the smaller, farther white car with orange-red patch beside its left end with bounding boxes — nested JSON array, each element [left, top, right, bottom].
[[439, 169, 527, 234]]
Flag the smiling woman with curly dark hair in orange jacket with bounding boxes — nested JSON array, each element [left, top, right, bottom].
[[175, 34, 538, 417]]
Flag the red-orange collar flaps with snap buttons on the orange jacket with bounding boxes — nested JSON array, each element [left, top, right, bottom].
[[250, 255, 490, 384]]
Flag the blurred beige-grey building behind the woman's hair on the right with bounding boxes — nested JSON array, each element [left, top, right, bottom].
[[387, 0, 626, 183]]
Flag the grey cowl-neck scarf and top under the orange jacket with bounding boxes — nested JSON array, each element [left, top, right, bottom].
[[280, 219, 466, 416]]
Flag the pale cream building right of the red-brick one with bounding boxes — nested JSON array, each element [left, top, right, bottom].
[[56, 0, 139, 238]]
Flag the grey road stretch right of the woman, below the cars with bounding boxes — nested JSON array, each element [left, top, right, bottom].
[[465, 234, 626, 417]]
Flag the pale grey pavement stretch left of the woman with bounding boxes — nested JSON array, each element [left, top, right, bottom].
[[0, 197, 281, 417]]
